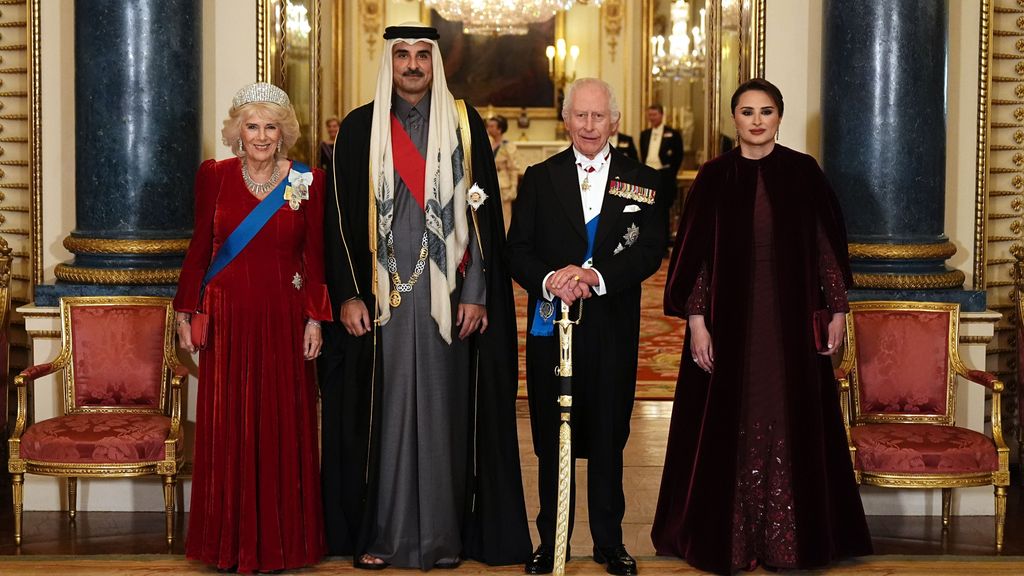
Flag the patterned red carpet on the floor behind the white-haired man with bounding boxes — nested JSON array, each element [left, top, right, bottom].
[[513, 260, 685, 400]]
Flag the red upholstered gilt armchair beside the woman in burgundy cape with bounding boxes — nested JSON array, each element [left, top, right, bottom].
[[837, 301, 1010, 550]]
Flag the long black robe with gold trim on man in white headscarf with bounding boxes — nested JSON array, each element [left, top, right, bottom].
[[318, 99, 531, 565]]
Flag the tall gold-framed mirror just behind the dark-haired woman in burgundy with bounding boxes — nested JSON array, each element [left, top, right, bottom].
[[641, 0, 765, 168]]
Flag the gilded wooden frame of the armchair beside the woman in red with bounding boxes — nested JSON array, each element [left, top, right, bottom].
[[7, 296, 188, 545]]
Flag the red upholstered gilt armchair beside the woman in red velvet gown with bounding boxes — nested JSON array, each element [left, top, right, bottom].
[[7, 296, 188, 544]]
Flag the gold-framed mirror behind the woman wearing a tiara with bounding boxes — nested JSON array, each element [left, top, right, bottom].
[[256, 0, 321, 166]]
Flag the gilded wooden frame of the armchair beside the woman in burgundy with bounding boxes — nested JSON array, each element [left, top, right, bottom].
[[836, 301, 1010, 550]]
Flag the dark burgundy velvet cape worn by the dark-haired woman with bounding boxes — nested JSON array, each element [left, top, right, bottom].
[[651, 145, 871, 573]]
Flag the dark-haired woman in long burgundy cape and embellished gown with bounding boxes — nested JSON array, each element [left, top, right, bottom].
[[651, 79, 871, 574]]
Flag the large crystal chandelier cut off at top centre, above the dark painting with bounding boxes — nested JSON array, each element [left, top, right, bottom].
[[424, 0, 601, 36]]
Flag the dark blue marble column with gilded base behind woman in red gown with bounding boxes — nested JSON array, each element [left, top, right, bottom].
[[35, 0, 203, 305]]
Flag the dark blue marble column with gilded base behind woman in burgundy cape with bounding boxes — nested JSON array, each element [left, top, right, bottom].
[[821, 0, 985, 312]]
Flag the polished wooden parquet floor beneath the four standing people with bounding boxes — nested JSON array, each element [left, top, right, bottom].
[[0, 401, 1024, 575]]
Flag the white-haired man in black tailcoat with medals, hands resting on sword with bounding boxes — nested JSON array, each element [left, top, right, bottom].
[[505, 78, 672, 574]]
